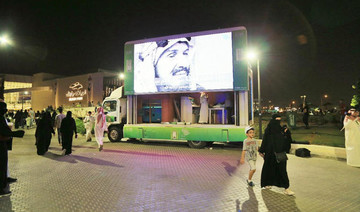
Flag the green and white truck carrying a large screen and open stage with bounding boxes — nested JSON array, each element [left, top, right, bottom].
[[103, 27, 253, 148]]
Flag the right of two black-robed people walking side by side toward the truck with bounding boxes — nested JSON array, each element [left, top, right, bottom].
[[60, 111, 77, 155]]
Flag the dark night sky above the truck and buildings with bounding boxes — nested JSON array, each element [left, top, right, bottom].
[[0, 0, 360, 106]]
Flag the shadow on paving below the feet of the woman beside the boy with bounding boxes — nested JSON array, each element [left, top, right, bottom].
[[261, 189, 300, 212]]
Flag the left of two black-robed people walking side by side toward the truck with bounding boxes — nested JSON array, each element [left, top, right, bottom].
[[35, 112, 55, 155]]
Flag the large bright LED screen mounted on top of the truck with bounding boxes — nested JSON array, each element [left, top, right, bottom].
[[133, 32, 233, 94]]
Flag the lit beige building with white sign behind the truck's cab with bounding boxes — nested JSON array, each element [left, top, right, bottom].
[[0, 69, 122, 110]]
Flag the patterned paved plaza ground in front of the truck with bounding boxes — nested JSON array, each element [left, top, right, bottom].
[[0, 129, 360, 212]]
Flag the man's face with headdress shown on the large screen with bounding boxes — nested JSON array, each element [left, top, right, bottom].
[[154, 38, 196, 92]]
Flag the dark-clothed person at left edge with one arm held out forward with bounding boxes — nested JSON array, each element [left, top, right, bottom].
[[0, 101, 24, 196]]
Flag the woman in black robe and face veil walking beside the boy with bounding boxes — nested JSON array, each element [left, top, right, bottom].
[[259, 114, 295, 195]]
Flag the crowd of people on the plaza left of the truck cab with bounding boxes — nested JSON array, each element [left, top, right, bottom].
[[0, 99, 107, 196]]
